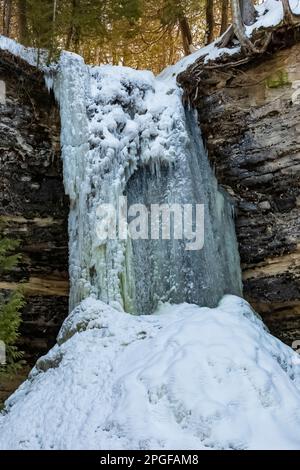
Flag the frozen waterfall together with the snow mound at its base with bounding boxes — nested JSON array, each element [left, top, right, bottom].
[[4, 34, 300, 455]]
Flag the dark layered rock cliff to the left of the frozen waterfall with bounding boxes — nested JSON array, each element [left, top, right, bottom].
[[0, 52, 69, 364]]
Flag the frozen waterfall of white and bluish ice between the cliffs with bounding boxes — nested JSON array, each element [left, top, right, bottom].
[[54, 53, 241, 313]]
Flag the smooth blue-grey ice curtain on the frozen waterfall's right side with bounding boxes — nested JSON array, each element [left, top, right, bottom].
[[122, 110, 241, 313]]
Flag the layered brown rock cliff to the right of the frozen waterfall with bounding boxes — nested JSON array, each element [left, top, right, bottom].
[[179, 44, 300, 345]]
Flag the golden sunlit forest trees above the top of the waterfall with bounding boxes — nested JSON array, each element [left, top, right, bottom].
[[0, 0, 260, 73]]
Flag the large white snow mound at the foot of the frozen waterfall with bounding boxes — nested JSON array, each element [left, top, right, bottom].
[[0, 296, 300, 449]]
